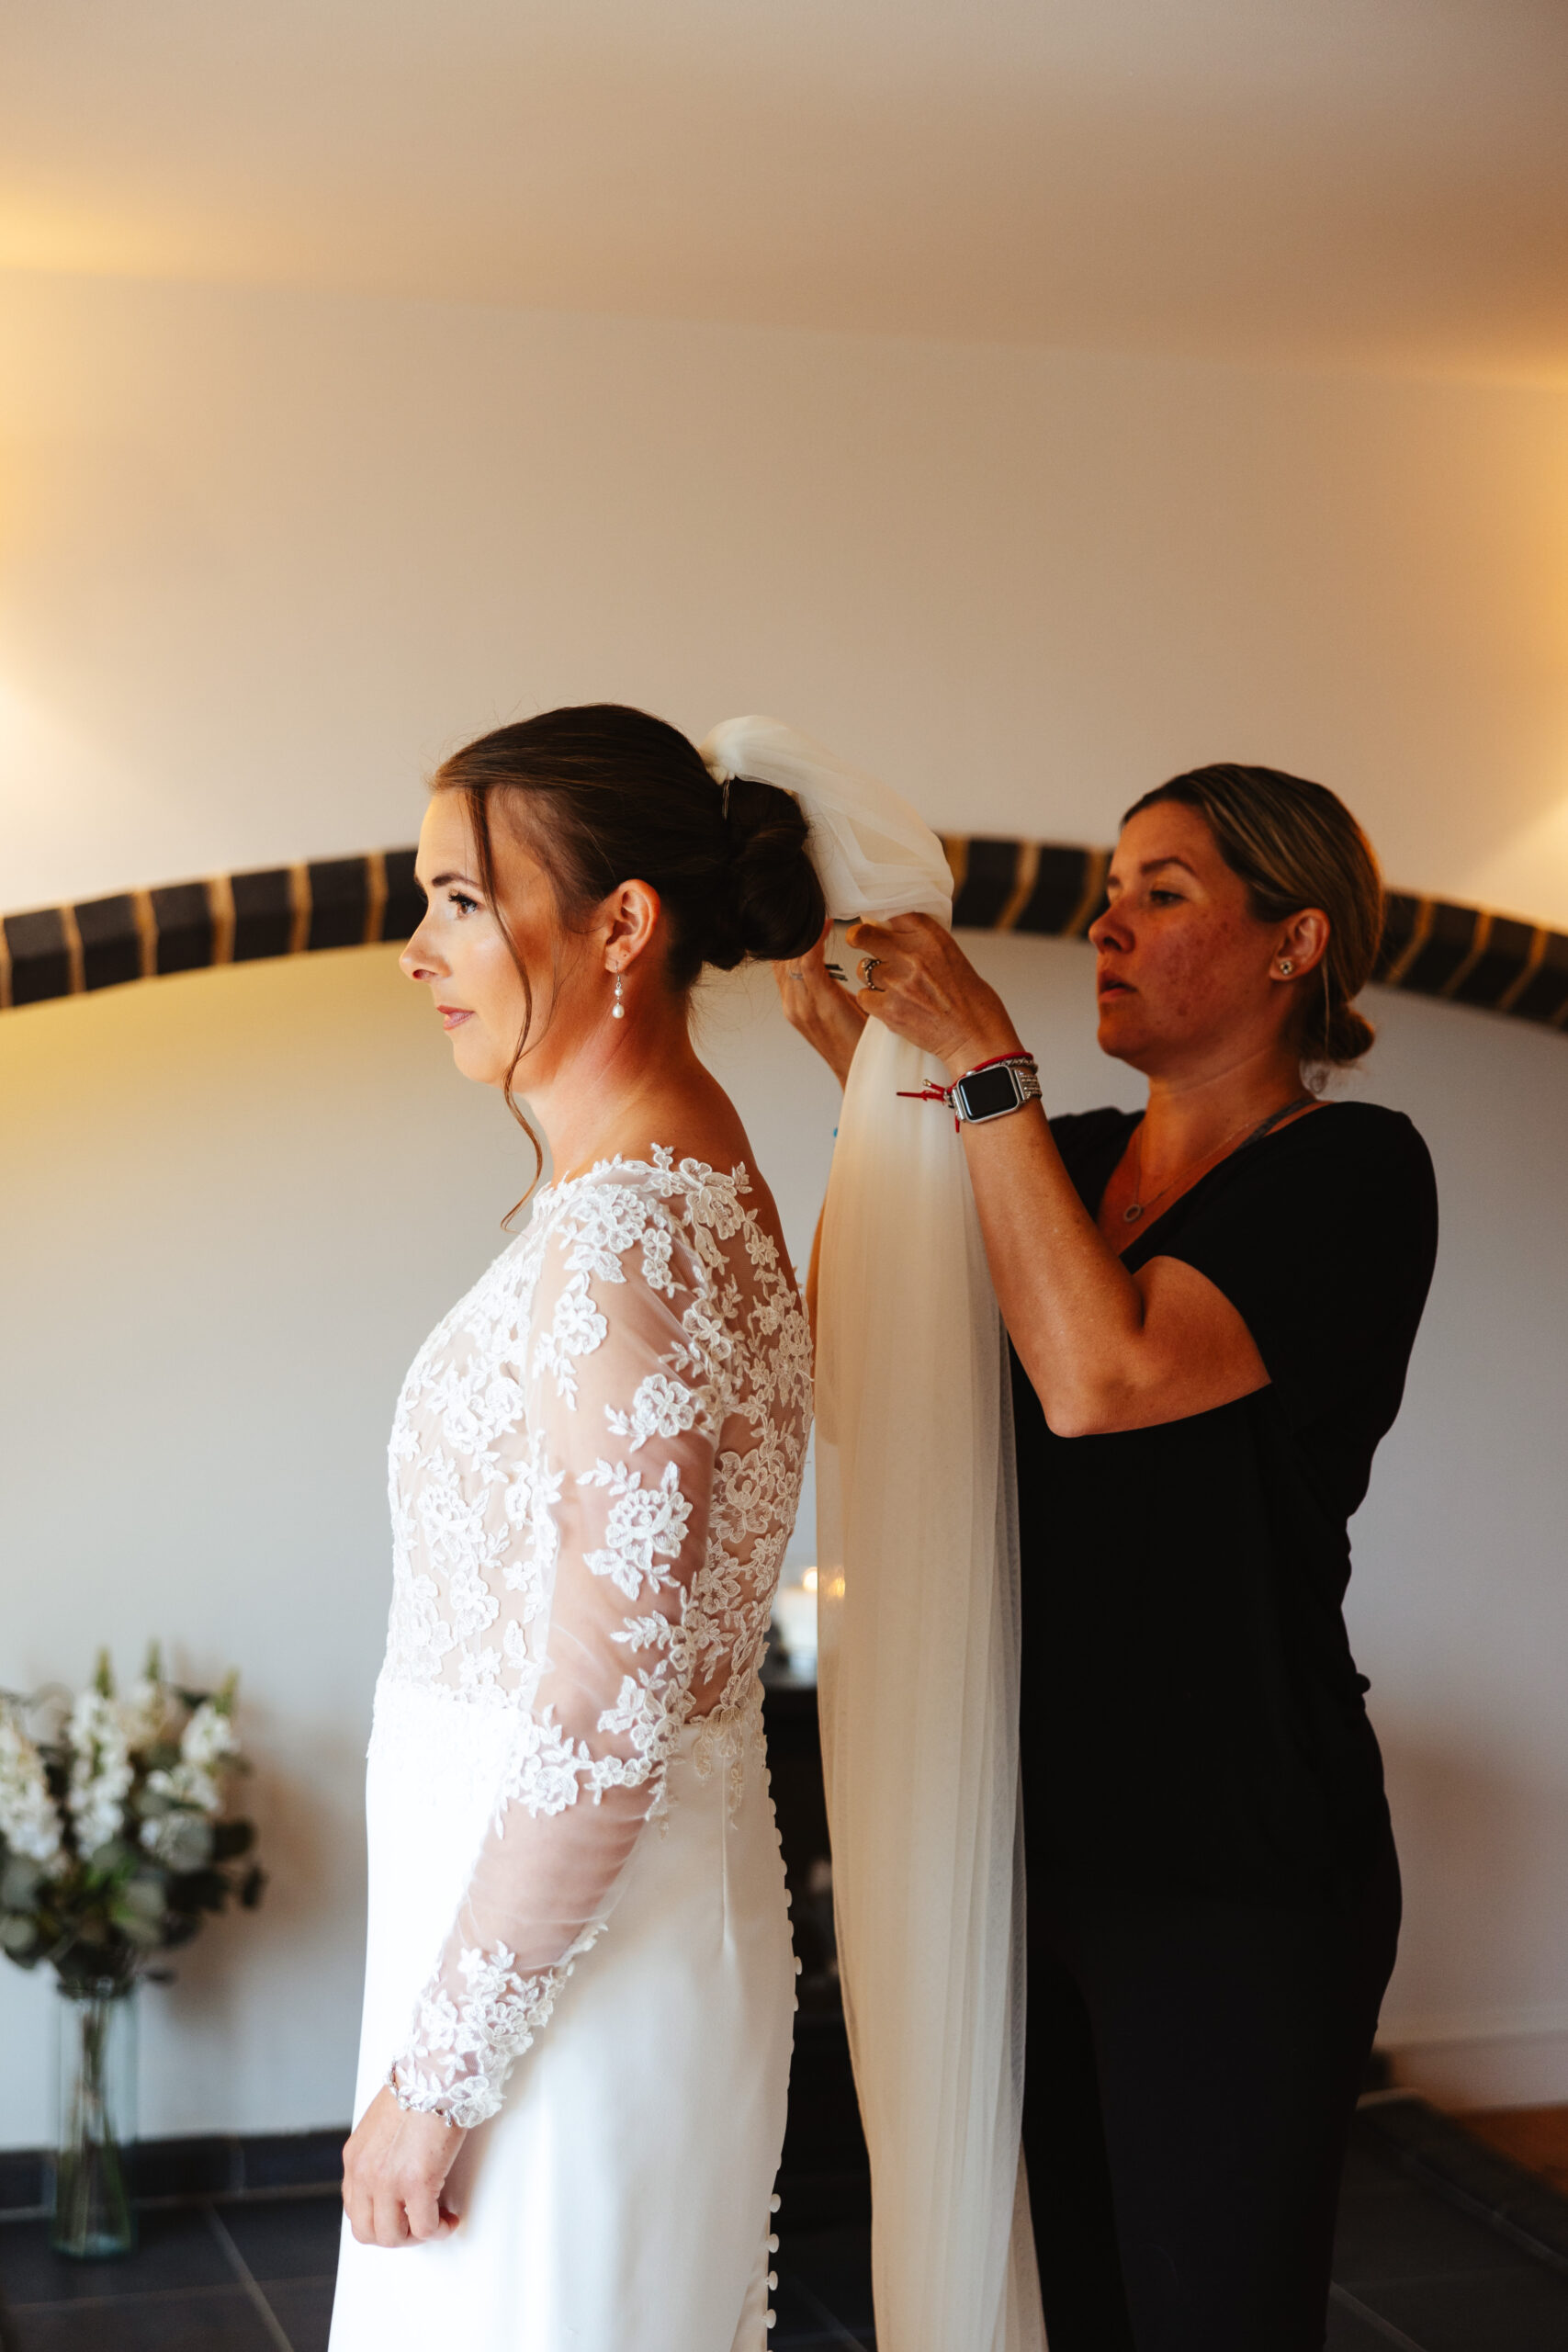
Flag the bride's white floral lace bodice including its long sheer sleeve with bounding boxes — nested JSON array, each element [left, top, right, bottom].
[[376, 1148, 811, 2124]]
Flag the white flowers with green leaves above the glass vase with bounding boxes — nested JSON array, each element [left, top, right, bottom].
[[0, 1646, 265, 1992]]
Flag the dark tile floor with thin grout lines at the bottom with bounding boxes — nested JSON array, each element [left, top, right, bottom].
[[0, 2121, 1568, 2352]]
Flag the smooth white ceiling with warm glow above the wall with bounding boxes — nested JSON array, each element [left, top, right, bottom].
[[0, 0, 1568, 374]]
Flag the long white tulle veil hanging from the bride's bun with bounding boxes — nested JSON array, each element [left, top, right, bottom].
[[703, 718, 1043, 2352]]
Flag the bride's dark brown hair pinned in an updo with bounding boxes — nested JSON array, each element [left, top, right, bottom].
[[433, 703, 828, 990]]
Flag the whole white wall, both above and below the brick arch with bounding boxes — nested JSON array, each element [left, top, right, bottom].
[[0, 277, 1568, 2143]]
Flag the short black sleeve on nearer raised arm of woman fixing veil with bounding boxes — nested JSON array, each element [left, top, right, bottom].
[[1149, 1103, 1437, 1425]]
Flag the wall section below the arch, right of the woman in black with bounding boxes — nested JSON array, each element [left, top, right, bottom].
[[1347, 992, 1568, 2105]]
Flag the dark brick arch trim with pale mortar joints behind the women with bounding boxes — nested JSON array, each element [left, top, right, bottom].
[[0, 835, 1568, 1030]]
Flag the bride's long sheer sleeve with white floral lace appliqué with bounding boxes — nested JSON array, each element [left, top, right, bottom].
[[388, 1183, 727, 2124]]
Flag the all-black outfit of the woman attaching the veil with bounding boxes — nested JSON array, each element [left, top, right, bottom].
[[1013, 1103, 1437, 2352]]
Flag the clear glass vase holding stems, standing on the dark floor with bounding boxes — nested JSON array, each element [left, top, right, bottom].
[[50, 1978, 136, 2263]]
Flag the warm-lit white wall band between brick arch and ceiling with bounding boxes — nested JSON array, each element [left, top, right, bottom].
[[0, 276, 1568, 924]]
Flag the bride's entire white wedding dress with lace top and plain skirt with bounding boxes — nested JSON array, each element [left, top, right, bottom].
[[332, 1150, 811, 2352]]
